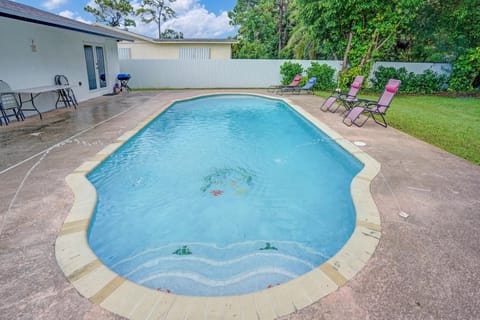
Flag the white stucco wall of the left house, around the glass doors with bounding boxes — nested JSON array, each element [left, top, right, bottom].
[[0, 17, 119, 115]]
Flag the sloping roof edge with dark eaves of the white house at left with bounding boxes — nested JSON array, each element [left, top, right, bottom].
[[0, 0, 134, 41]]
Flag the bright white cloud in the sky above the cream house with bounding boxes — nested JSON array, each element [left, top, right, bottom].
[[129, 0, 235, 38]]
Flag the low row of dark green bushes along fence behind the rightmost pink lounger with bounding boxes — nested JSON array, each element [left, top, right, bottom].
[[372, 66, 447, 94]]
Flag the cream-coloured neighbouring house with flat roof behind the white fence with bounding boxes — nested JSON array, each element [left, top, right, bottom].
[[97, 25, 236, 60]]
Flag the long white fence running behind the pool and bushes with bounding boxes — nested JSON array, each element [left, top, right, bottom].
[[120, 59, 450, 89]]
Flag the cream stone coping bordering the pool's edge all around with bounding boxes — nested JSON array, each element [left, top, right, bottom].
[[55, 92, 381, 319]]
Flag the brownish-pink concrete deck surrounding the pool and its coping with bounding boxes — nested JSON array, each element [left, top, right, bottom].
[[0, 90, 480, 319]]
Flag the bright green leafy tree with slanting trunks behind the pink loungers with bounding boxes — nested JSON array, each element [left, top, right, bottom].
[[287, 0, 422, 79]]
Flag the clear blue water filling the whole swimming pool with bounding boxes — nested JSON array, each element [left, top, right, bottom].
[[88, 95, 363, 296]]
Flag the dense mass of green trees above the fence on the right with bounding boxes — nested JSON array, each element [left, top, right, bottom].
[[229, 0, 480, 66]]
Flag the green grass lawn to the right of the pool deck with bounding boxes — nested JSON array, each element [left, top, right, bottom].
[[321, 93, 480, 165]]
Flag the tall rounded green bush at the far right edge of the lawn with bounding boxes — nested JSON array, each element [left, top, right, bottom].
[[448, 47, 480, 92]]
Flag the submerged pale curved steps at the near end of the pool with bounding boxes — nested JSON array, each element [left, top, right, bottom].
[[105, 240, 327, 296]]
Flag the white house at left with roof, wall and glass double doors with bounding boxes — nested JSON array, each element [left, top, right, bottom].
[[0, 0, 133, 117]]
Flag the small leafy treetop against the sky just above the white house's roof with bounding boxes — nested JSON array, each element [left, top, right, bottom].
[[83, 0, 135, 27]]
